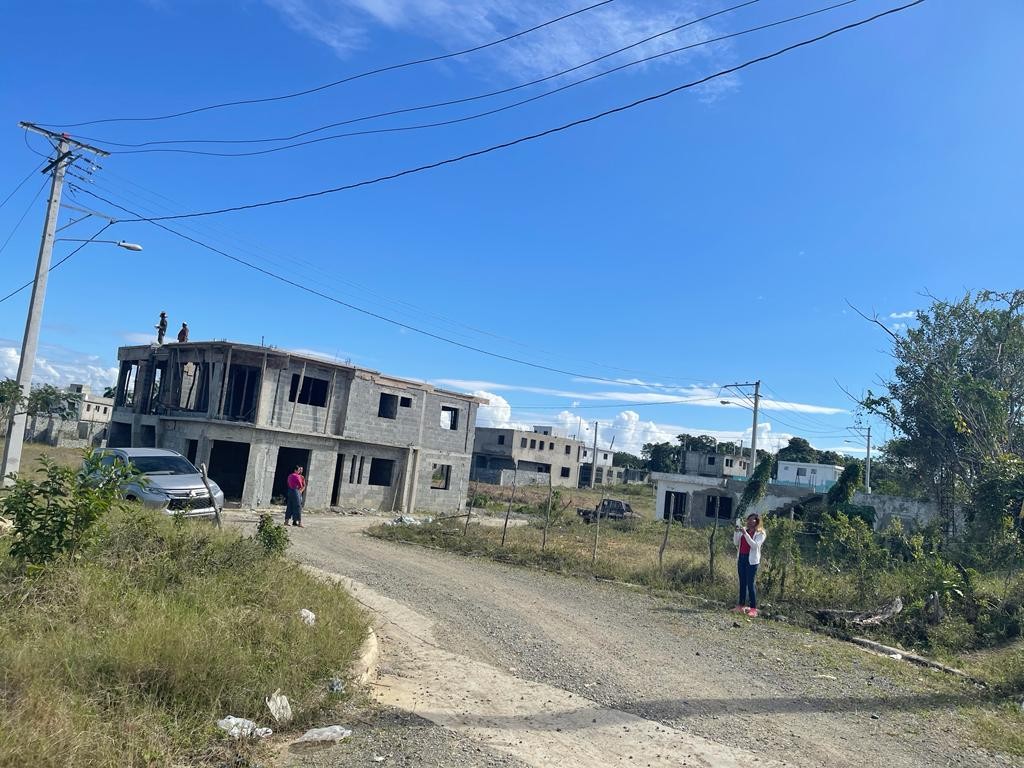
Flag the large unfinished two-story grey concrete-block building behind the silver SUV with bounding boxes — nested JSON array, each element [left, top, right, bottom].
[[108, 341, 485, 513]]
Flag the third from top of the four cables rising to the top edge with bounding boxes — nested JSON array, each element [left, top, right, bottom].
[[111, 0, 857, 158]]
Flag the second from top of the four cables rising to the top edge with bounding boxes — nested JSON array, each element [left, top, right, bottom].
[[75, 0, 765, 154]]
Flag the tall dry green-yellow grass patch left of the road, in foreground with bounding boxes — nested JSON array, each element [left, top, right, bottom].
[[0, 508, 367, 768]]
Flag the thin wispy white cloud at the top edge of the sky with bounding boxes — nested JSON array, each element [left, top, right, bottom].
[[265, 0, 735, 79]]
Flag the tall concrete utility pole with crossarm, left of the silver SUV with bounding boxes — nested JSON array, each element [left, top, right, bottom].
[[0, 122, 110, 486]]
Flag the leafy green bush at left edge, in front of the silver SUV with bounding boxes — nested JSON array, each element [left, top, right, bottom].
[[0, 453, 137, 565]]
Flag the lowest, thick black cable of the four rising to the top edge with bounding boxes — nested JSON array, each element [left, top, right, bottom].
[[112, 0, 925, 222]]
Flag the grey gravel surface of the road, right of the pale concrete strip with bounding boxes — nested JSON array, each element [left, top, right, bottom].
[[241, 515, 1017, 768]]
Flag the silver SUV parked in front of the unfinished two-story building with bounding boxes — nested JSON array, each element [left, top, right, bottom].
[[100, 447, 224, 517]]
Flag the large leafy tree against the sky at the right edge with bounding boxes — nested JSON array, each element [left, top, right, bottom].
[[861, 290, 1024, 535]]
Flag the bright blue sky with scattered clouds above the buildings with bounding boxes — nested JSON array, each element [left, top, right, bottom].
[[0, 0, 1024, 451]]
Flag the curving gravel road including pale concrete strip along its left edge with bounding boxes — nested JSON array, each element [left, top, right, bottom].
[[235, 515, 1013, 768]]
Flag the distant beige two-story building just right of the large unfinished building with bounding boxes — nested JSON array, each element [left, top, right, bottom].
[[470, 426, 583, 487]]
